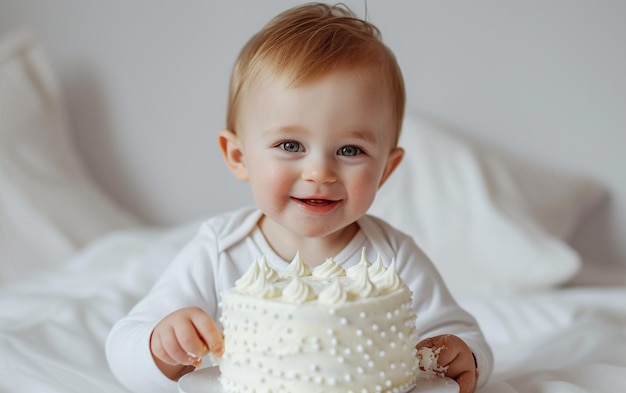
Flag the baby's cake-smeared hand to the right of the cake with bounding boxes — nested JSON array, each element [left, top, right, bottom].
[[416, 334, 478, 393]]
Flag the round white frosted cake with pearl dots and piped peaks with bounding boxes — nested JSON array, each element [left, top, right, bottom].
[[219, 251, 418, 393]]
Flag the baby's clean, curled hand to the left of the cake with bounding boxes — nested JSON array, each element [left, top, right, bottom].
[[150, 307, 224, 379]]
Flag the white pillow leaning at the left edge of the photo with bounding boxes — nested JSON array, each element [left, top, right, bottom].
[[0, 33, 139, 285]]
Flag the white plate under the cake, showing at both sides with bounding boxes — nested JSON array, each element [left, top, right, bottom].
[[178, 367, 459, 393]]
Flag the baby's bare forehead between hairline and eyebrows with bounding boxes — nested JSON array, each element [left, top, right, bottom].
[[237, 71, 396, 140]]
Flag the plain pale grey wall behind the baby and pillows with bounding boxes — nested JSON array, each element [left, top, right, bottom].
[[0, 0, 626, 263]]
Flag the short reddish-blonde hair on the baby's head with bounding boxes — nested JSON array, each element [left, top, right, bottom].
[[226, 3, 406, 141]]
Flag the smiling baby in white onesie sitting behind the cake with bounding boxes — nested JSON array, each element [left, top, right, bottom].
[[107, 4, 493, 393]]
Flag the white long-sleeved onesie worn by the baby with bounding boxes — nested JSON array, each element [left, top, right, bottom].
[[106, 207, 493, 393]]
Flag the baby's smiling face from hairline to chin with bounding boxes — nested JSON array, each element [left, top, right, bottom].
[[237, 72, 402, 243]]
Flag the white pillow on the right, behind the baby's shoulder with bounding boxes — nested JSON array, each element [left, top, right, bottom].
[[370, 111, 605, 297]]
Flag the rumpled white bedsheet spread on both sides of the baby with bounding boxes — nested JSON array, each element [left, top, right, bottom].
[[0, 224, 626, 393]]
